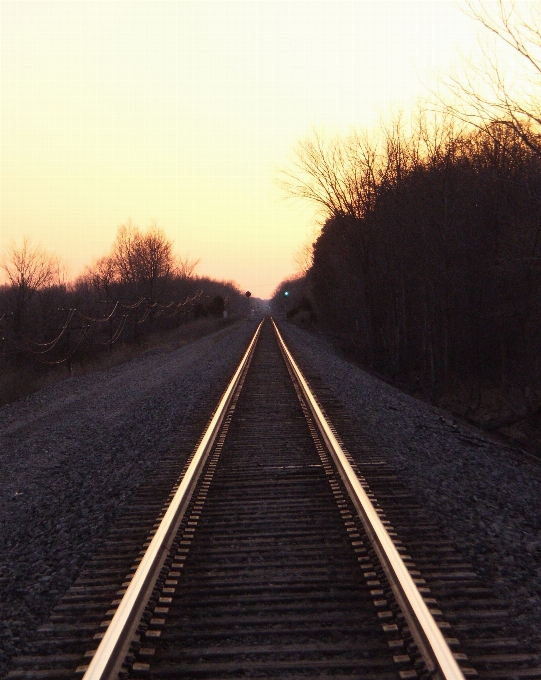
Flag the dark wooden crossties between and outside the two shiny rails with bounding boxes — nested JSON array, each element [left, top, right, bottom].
[[8, 322, 541, 679]]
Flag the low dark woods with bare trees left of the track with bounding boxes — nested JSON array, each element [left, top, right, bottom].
[[0, 223, 249, 401]]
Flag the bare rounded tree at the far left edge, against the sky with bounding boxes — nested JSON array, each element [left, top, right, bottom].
[[0, 237, 61, 332]]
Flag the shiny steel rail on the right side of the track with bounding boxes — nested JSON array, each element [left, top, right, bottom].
[[272, 319, 464, 680]]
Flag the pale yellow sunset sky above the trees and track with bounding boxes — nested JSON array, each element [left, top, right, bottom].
[[0, 0, 478, 298]]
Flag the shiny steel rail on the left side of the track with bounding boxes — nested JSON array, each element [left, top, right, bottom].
[[83, 321, 263, 680]]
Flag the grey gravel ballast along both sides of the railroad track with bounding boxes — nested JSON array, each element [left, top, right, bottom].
[[0, 320, 541, 676]]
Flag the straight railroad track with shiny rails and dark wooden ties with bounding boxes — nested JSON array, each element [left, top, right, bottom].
[[7, 320, 541, 680]]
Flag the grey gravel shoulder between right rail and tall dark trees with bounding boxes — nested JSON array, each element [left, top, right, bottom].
[[279, 322, 541, 652]]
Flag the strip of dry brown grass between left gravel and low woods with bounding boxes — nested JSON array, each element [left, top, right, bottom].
[[0, 316, 243, 406]]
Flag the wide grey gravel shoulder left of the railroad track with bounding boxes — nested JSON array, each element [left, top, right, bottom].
[[0, 320, 256, 676]]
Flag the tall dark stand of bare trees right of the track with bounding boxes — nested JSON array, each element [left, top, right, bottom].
[[273, 3, 541, 426]]
